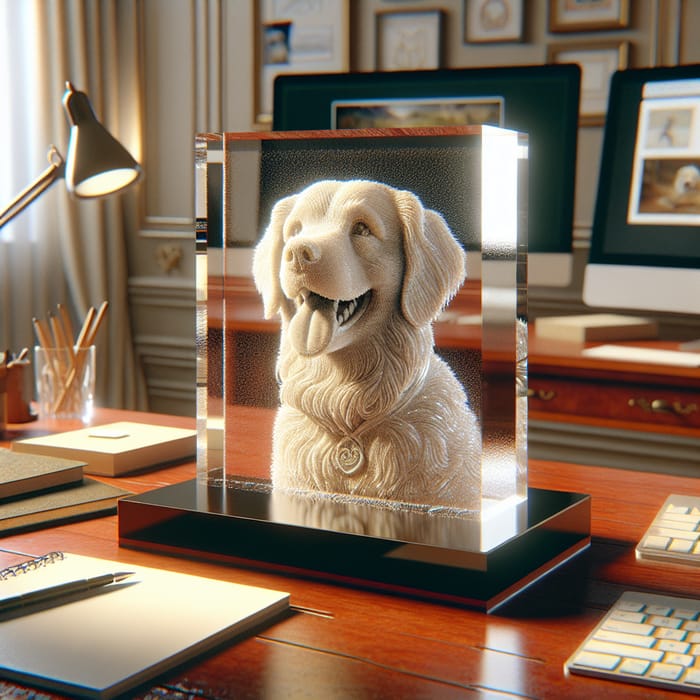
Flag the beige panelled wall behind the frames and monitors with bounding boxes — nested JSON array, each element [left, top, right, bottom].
[[129, 0, 700, 414]]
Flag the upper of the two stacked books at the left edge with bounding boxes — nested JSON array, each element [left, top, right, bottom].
[[0, 447, 84, 502]]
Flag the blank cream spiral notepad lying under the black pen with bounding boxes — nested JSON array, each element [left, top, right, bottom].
[[0, 553, 289, 698]]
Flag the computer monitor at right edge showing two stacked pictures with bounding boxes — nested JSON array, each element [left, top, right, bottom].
[[583, 65, 700, 314]]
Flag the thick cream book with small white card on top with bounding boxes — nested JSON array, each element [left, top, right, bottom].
[[12, 421, 197, 476]]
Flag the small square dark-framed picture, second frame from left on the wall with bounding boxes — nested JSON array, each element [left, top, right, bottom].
[[375, 10, 442, 71]]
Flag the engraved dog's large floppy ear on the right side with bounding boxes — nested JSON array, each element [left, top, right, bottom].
[[396, 191, 466, 327]]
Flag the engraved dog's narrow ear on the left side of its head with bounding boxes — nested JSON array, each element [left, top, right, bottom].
[[253, 195, 297, 318]]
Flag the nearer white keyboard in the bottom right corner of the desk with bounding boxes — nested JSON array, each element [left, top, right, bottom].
[[564, 591, 700, 695]]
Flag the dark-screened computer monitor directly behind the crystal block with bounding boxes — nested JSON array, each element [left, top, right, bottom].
[[272, 65, 581, 286]]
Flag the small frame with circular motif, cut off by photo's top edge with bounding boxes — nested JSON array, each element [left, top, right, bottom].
[[464, 0, 523, 44]]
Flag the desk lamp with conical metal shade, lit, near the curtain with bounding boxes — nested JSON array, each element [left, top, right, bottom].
[[0, 82, 141, 228]]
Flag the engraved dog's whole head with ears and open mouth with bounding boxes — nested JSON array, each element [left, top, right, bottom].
[[253, 180, 465, 357]]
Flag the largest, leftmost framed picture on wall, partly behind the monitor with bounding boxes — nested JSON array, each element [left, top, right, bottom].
[[255, 0, 350, 126]]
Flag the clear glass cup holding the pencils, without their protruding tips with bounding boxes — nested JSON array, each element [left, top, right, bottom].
[[34, 345, 95, 423]]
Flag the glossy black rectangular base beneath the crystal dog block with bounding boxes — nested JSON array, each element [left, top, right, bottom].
[[119, 480, 591, 611]]
